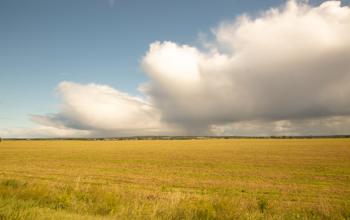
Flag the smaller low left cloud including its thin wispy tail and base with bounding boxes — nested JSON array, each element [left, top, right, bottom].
[[28, 82, 180, 136]]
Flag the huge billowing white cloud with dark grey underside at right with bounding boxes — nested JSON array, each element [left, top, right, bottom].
[[143, 1, 350, 133]]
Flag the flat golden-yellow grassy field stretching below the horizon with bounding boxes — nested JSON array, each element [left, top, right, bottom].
[[0, 139, 350, 219]]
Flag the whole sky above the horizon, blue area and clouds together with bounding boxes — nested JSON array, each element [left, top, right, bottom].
[[0, 0, 350, 137]]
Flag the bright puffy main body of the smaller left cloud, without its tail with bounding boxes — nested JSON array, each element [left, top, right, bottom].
[[58, 82, 160, 130]]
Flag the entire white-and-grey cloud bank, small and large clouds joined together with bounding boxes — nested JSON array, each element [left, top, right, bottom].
[[2, 1, 350, 136]]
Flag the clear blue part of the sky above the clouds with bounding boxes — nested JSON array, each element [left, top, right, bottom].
[[0, 0, 348, 138]]
